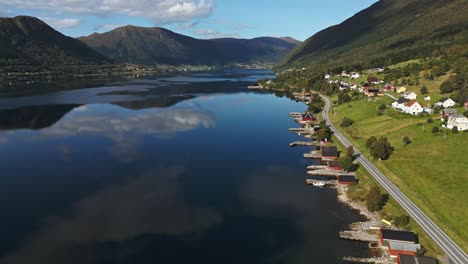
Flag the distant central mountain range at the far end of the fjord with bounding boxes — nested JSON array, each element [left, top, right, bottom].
[[79, 26, 299, 65]]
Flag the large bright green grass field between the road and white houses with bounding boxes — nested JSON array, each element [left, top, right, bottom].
[[331, 97, 468, 251]]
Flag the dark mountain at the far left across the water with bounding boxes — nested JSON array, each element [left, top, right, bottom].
[[0, 16, 112, 66]]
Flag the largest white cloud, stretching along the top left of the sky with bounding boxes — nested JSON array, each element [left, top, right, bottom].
[[0, 0, 215, 23]]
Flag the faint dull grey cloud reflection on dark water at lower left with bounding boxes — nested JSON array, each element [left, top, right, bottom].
[[0, 167, 222, 264]]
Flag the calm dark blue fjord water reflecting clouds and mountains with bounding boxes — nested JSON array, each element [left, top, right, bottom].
[[0, 70, 368, 264]]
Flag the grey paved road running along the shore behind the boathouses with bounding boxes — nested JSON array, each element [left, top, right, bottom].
[[321, 95, 468, 264]]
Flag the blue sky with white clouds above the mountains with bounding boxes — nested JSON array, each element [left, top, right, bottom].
[[0, 0, 378, 41]]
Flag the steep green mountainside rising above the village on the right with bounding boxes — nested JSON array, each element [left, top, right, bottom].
[[276, 0, 468, 70]]
